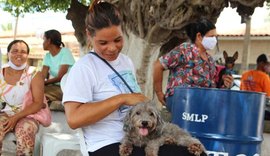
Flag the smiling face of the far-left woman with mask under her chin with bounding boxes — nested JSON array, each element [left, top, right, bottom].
[[8, 42, 28, 66]]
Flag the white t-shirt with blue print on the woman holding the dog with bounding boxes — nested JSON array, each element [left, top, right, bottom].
[[63, 53, 141, 152]]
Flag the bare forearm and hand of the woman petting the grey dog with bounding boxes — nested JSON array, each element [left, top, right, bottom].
[[64, 93, 148, 129]]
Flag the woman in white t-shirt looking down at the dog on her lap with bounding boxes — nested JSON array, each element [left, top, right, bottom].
[[63, 1, 204, 156]]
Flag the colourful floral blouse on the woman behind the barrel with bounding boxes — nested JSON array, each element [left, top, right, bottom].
[[159, 43, 217, 97]]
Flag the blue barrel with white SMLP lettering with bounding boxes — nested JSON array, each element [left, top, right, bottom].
[[171, 88, 265, 156]]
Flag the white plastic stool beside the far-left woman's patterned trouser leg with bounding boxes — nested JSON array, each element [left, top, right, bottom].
[[40, 133, 80, 156]]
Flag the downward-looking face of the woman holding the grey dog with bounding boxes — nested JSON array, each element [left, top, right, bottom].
[[90, 25, 124, 61]]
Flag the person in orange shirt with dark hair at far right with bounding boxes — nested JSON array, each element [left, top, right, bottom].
[[240, 54, 270, 120]]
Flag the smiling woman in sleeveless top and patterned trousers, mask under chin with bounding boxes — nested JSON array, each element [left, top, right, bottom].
[[0, 40, 44, 155]]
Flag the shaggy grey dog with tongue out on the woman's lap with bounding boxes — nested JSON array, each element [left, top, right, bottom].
[[119, 101, 205, 156]]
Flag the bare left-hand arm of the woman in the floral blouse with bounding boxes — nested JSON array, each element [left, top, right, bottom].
[[153, 60, 165, 105]]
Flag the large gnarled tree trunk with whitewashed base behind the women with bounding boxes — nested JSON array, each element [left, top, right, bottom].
[[66, 0, 265, 98]]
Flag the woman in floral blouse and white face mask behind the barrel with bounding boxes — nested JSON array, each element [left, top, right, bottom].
[[154, 19, 233, 106]]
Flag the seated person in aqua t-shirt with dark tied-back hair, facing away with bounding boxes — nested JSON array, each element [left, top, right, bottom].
[[42, 29, 75, 103]]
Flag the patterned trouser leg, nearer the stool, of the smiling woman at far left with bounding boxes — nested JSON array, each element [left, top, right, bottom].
[[15, 118, 39, 156]]
